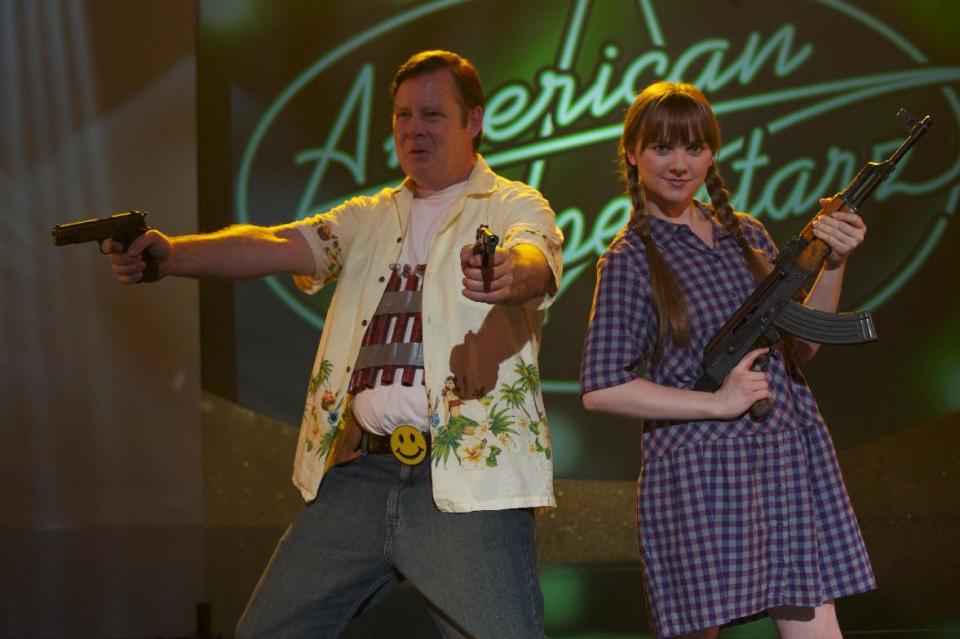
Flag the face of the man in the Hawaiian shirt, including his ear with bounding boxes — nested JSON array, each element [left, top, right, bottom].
[[393, 69, 483, 196]]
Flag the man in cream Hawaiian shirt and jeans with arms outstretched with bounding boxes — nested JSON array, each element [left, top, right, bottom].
[[105, 51, 562, 639]]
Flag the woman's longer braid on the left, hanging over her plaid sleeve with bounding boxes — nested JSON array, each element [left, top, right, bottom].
[[624, 162, 690, 362]]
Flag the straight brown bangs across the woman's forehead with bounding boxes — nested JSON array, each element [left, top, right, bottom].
[[640, 93, 720, 151]]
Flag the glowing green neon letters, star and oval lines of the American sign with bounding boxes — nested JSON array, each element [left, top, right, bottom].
[[237, 0, 960, 356]]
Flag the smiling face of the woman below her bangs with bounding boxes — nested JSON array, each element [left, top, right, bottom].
[[627, 142, 713, 215]]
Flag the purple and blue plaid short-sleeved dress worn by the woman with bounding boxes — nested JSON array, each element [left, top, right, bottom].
[[581, 209, 876, 637]]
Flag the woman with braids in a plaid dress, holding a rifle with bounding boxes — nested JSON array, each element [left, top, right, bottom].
[[581, 82, 875, 638]]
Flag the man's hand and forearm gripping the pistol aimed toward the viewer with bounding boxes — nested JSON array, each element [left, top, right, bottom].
[[460, 244, 556, 304]]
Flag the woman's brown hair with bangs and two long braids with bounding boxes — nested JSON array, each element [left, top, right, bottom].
[[618, 82, 770, 361]]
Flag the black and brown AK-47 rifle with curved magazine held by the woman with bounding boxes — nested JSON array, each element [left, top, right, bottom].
[[694, 109, 933, 419]]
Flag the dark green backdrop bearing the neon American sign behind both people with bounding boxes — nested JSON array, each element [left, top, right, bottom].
[[198, 0, 960, 479]]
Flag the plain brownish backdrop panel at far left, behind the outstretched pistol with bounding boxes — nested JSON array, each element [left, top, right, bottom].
[[0, 0, 206, 639]]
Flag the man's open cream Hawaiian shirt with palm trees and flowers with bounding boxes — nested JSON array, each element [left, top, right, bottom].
[[293, 156, 563, 512]]
